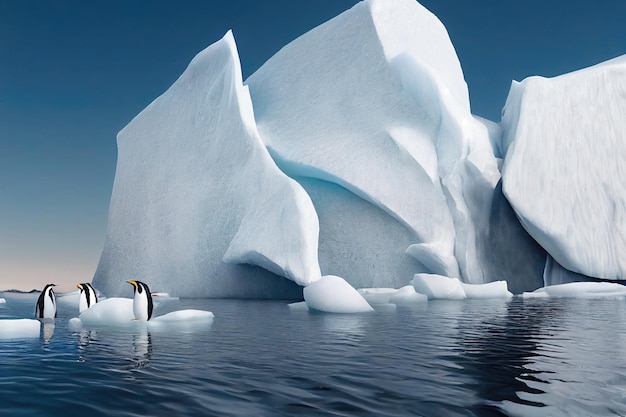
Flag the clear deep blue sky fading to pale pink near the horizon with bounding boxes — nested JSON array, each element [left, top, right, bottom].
[[0, 0, 626, 290]]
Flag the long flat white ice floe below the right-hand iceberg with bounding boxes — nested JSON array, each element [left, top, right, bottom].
[[522, 282, 626, 298]]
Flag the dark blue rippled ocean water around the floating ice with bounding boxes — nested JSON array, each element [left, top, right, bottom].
[[0, 294, 626, 417]]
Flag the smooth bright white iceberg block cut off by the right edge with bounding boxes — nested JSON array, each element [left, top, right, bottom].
[[502, 55, 626, 279]]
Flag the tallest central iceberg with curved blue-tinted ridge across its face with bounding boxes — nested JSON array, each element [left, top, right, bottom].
[[246, 0, 499, 288]]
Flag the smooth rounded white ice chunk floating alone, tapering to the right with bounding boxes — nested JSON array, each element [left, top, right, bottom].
[[303, 275, 374, 313]]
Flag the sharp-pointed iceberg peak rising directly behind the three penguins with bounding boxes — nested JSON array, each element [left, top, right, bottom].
[[93, 32, 321, 298]]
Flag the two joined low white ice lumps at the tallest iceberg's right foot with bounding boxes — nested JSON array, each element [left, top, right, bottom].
[[411, 274, 513, 300]]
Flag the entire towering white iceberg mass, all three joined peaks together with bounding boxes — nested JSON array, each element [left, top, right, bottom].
[[93, 0, 626, 299]]
